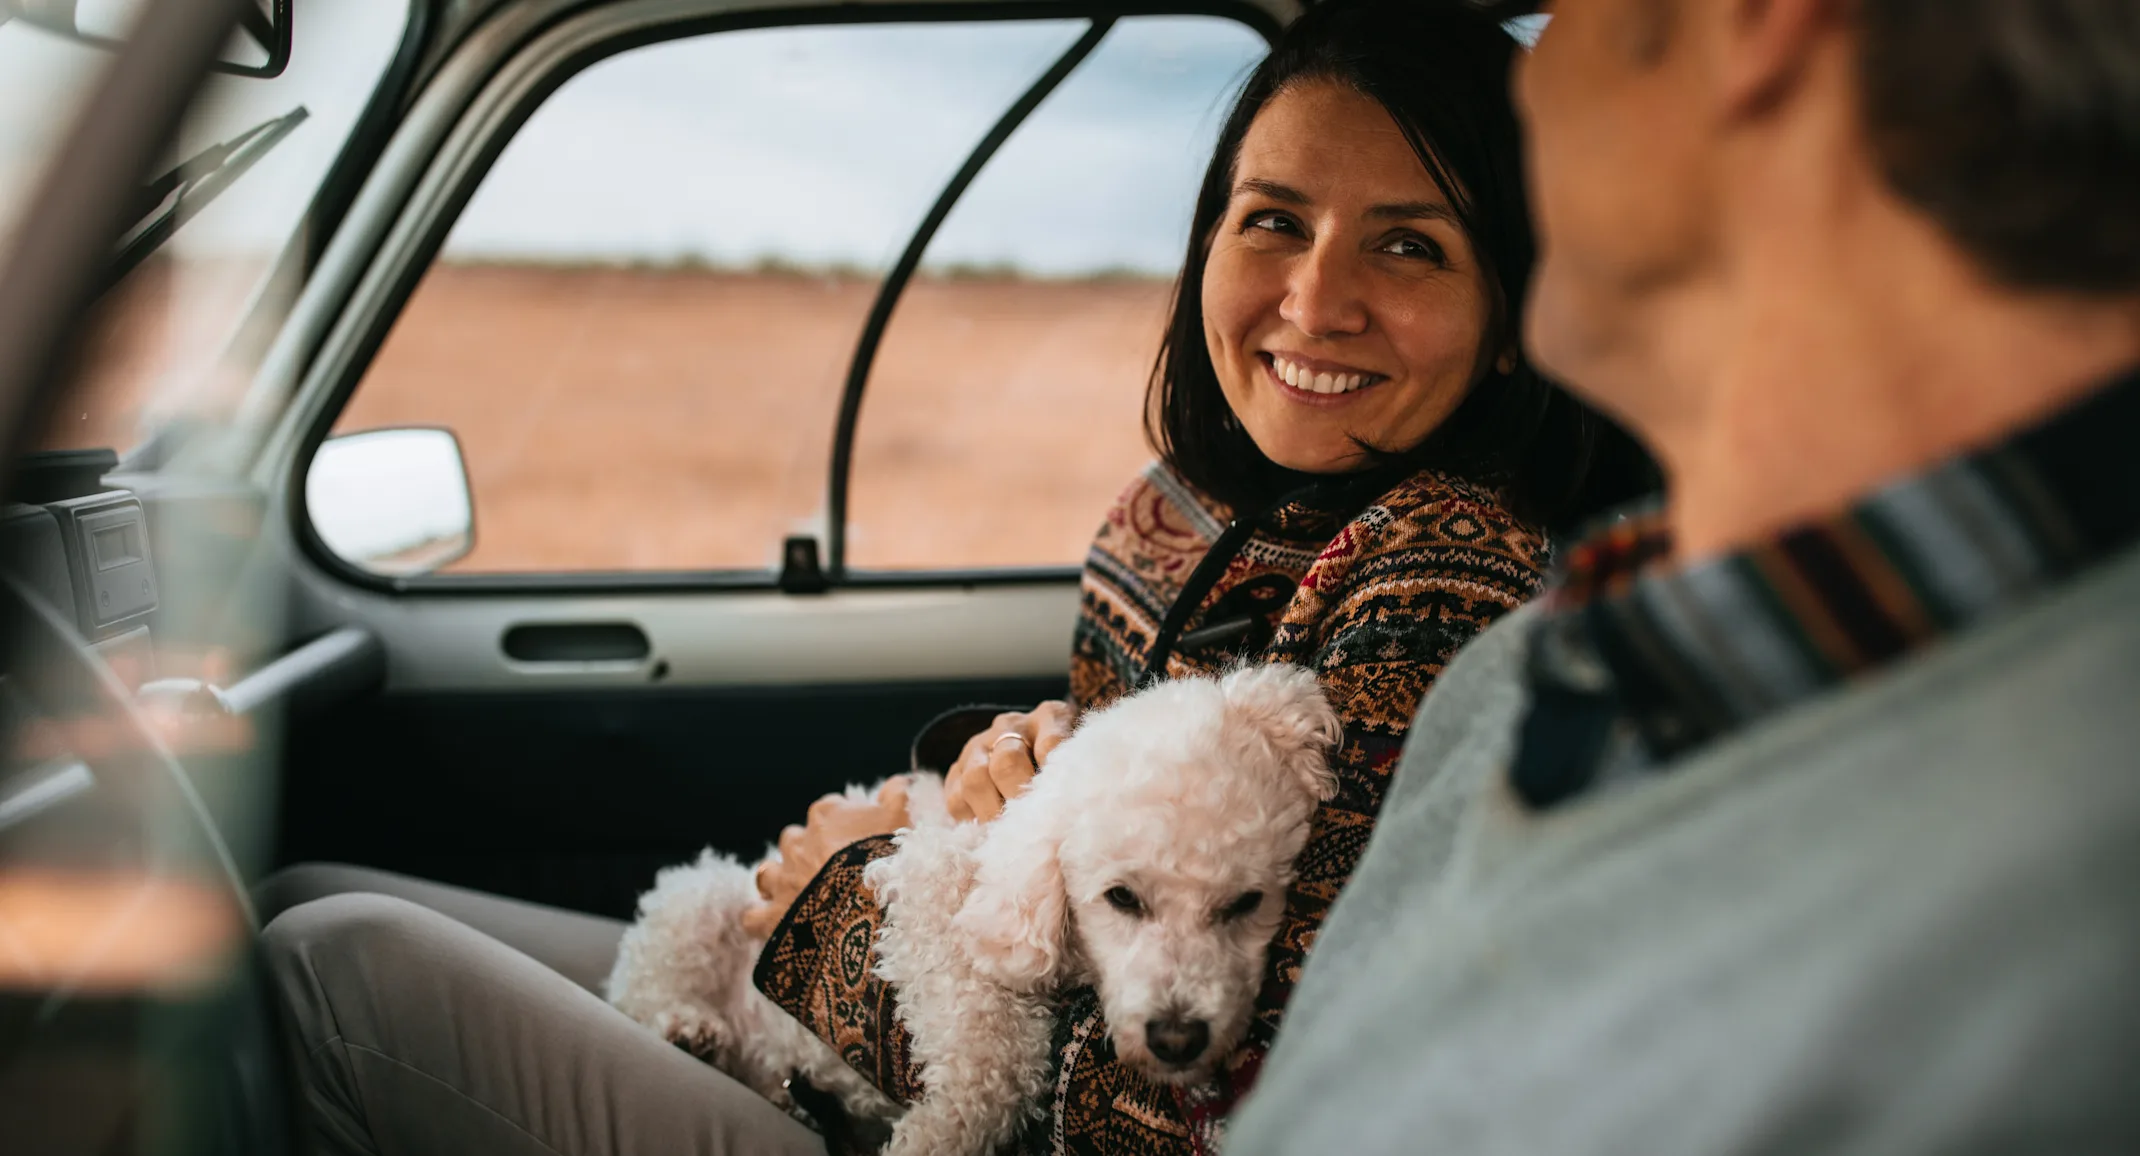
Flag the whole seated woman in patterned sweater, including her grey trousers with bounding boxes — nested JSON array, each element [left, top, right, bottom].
[[268, 0, 1652, 1154]]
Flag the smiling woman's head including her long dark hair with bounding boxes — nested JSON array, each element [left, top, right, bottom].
[[1147, 0, 1600, 527]]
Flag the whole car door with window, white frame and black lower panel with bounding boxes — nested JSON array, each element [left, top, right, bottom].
[[248, 0, 1290, 914]]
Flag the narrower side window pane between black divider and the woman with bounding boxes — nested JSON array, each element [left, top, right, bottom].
[[847, 17, 1265, 569]]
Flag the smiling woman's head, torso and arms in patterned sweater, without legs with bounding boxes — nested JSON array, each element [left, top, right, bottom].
[[736, 0, 1618, 1154]]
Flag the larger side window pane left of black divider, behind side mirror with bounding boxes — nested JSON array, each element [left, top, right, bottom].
[[334, 21, 1085, 572]]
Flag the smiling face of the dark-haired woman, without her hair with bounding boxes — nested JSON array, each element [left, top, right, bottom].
[[1203, 81, 1492, 473]]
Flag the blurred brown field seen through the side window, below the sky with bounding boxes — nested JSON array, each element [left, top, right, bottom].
[[66, 265, 1168, 572]]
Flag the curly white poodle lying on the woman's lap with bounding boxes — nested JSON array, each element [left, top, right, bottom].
[[610, 666, 1340, 1156]]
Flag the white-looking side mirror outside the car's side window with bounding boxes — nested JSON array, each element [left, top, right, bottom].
[[304, 428, 475, 578]]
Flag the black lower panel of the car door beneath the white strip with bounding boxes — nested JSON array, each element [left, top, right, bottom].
[[280, 676, 1064, 918]]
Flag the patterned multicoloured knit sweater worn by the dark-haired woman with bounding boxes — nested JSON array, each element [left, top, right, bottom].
[[758, 465, 1547, 1156]]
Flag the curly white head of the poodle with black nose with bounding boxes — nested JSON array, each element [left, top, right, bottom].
[[959, 666, 1340, 1081]]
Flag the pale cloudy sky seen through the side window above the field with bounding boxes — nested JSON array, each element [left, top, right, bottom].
[[447, 17, 1263, 276]]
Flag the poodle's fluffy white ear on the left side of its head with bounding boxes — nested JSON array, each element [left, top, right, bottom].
[[952, 775, 1070, 993]]
